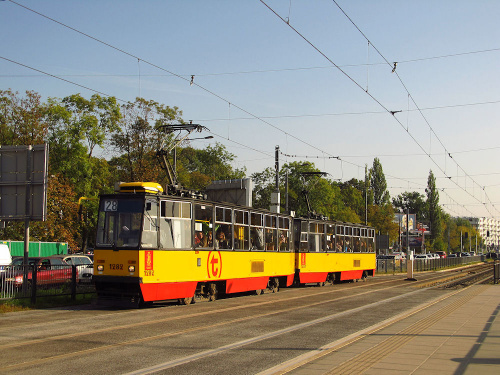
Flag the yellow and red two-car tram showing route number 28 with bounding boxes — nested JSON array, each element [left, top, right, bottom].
[[94, 182, 375, 305]]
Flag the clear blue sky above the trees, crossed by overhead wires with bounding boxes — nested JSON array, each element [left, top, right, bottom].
[[0, 0, 500, 219]]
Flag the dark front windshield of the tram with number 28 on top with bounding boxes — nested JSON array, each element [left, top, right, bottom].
[[96, 197, 144, 248]]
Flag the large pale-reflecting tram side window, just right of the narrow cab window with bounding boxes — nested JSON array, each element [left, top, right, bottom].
[[160, 201, 192, 249]]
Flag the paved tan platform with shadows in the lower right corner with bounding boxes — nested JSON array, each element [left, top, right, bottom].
[[281, 285, 500, 375]]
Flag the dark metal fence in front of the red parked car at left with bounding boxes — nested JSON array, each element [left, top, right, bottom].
[[0, 265, 95, 304]]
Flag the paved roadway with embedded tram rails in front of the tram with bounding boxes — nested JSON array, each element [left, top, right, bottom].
[[0, 275, 472, 375]]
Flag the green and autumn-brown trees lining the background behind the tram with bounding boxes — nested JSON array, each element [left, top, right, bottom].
[[0, 90, 460, 254]]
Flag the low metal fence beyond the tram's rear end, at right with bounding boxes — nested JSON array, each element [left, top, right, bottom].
[[376, 255, 484, 273]]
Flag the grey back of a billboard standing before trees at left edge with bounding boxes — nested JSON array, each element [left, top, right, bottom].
[[0, 144, 49, 221]]
